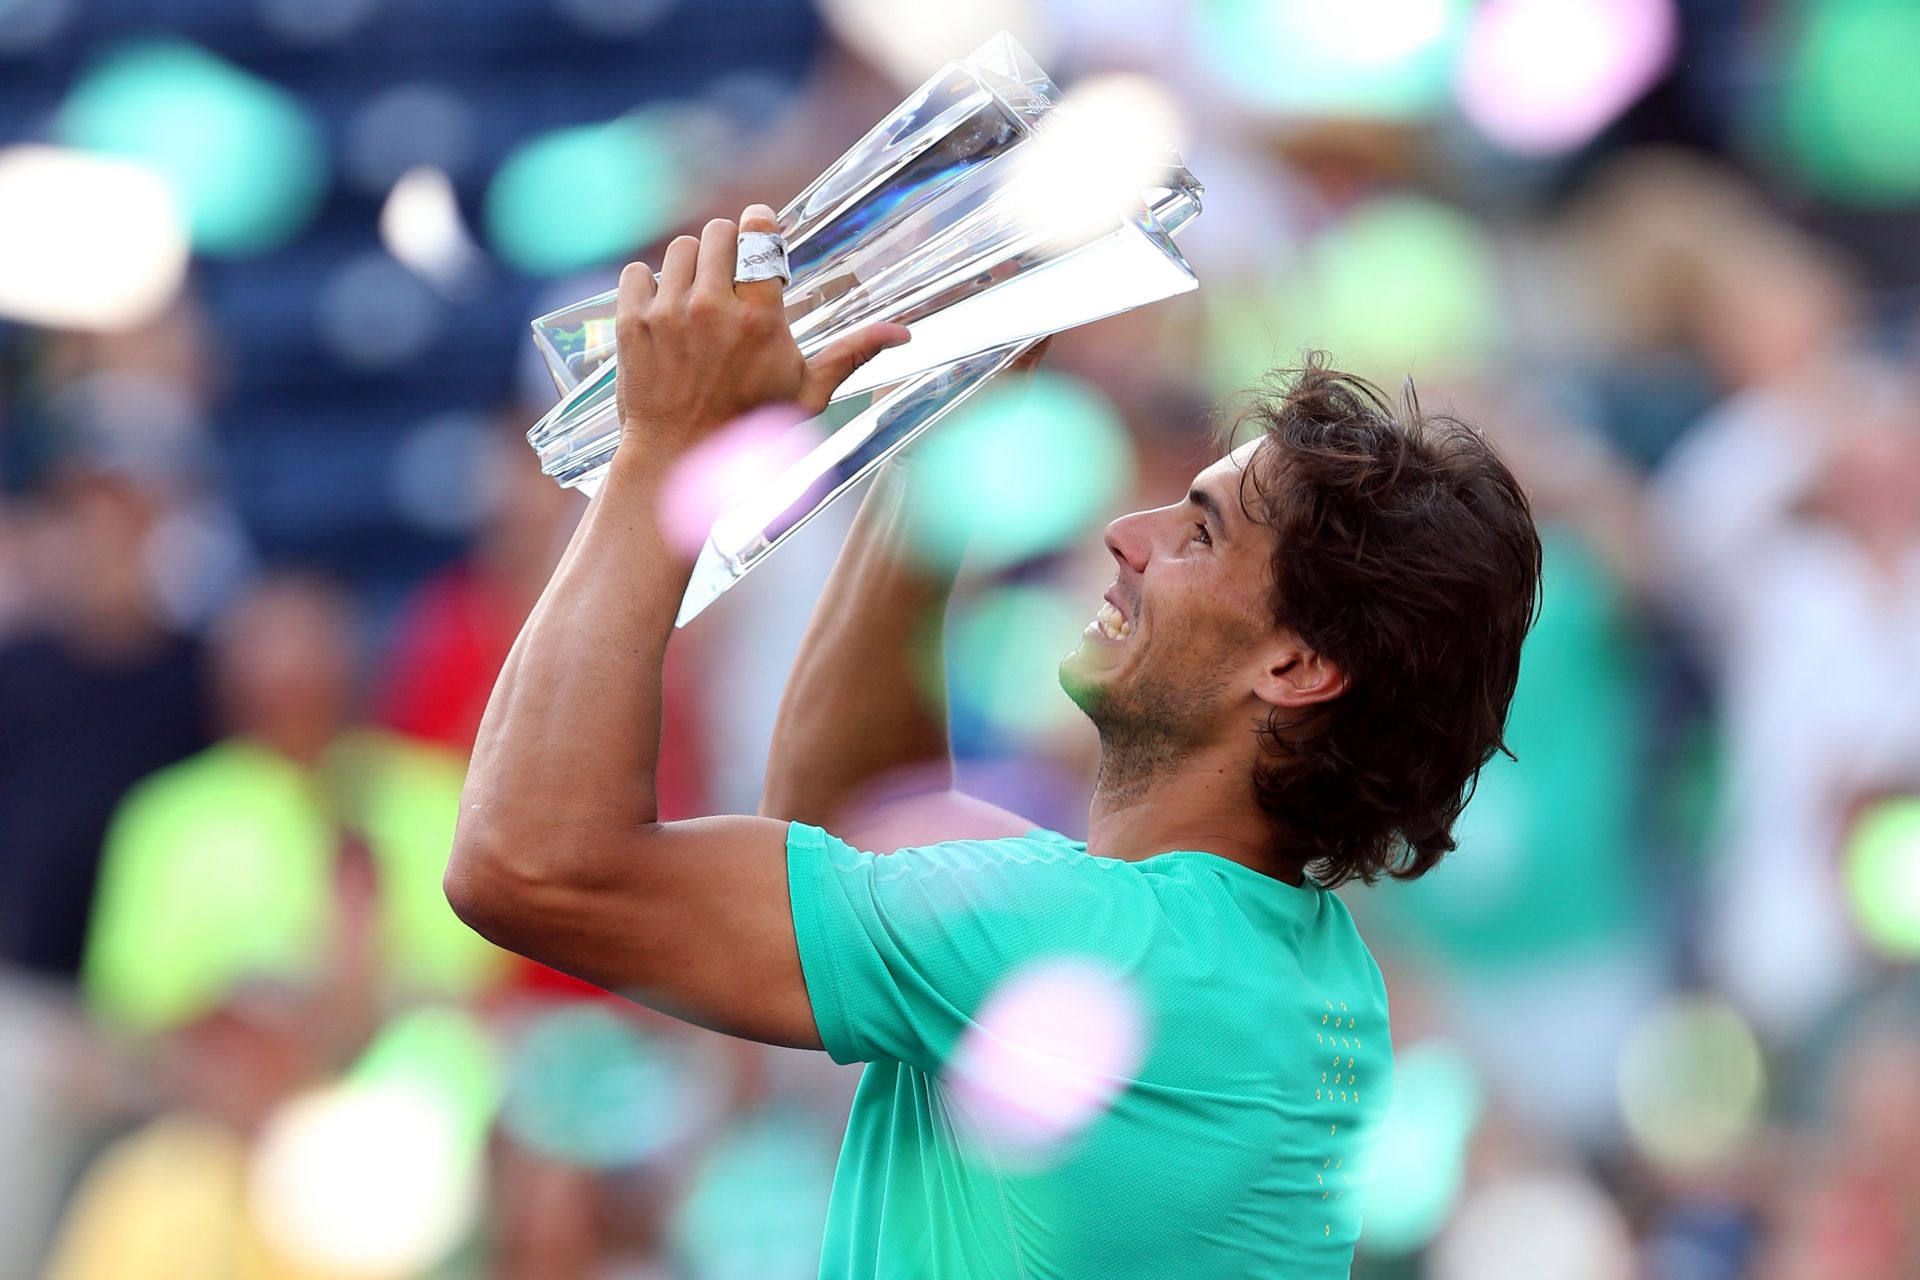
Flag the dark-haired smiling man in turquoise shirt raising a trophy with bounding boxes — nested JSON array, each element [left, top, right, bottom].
[[447, 205, 1540, 1278]]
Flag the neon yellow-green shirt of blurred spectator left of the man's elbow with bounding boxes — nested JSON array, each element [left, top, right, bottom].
[[81, 731, 503, 1032]]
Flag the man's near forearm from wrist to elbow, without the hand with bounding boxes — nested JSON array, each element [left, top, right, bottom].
[[449, 451, 691, 883]]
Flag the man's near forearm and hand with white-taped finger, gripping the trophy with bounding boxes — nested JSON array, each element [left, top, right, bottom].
[[445, 203, 912, 940]]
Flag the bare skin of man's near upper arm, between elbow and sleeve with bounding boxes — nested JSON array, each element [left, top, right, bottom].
[[534, 816, 820, 1050]]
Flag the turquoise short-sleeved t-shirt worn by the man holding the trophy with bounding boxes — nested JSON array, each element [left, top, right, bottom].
[[787, 823, 1392, 1280]]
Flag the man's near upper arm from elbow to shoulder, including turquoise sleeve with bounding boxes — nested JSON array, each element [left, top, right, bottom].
[[468, 818, 1102, 1071]]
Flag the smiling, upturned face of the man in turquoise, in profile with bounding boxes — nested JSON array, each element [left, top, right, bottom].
[[1060, 439, 1273, 750]]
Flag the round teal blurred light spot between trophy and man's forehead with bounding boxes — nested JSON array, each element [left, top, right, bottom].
[[910, 370, 1133, 568]]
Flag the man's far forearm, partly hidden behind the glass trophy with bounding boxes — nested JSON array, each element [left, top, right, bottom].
[[760, 461, 952, 823]]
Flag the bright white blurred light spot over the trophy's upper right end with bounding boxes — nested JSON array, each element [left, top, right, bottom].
[[1014, 75, 1187, 240]]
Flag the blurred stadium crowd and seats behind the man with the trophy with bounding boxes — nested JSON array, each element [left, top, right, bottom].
[[0, 0, 1920, 1280]]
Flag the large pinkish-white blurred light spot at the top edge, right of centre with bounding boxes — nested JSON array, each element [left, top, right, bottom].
[[1457, 0, 1678, 154]]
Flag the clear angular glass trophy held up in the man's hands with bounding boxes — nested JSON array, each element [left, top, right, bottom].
[[528, 33, 1202, 626]]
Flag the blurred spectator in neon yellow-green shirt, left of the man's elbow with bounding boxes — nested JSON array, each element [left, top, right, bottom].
[[84, 578, 499, 1050]]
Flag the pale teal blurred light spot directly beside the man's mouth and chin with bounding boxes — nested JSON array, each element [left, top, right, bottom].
[[947, 583, 1100, 743]]
